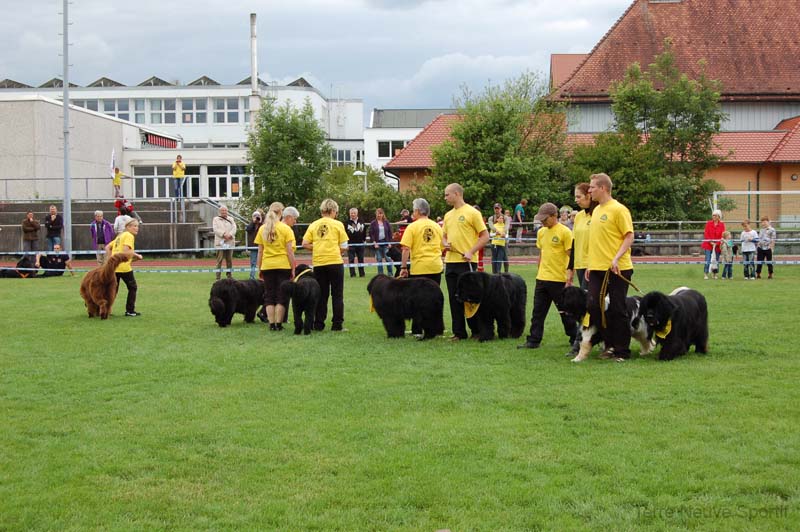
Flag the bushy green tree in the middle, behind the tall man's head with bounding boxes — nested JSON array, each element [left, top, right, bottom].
[[432, 73, 571, 212]]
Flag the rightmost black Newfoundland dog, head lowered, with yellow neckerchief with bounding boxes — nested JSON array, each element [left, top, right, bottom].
[[639, 286, 708, 360]]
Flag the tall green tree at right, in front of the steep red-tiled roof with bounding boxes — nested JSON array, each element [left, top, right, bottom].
[[569, 40, 724, 220]]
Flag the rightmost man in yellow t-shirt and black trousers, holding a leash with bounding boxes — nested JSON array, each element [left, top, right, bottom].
[[572, 174, 634, 362]]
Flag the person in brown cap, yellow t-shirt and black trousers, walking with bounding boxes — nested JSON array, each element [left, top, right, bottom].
[[519, 203, 578, 349]]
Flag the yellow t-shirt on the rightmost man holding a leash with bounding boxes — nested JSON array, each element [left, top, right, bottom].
[[589, 199, 633, 271]]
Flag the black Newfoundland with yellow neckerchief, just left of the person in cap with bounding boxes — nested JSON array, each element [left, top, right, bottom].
[[456, 272, 528, 342]]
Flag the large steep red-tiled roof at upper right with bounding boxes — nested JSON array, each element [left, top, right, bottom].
[[556, 0, 800, 101]]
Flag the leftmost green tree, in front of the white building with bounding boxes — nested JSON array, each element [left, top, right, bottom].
[[244, 99, 330, 210]]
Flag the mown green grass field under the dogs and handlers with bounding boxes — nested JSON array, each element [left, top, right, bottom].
[[0, 261, 800, 531]]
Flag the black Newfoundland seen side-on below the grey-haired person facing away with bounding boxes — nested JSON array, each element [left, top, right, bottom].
[[367, 274, 444, 340]]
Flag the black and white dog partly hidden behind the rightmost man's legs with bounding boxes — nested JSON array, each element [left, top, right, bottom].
[[561, 286, 655, 362]]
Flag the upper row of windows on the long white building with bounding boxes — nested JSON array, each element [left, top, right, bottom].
[[70, 97, 250, 124]]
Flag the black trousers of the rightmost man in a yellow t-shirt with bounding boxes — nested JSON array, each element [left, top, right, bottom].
[[589, 270, 633, 358]]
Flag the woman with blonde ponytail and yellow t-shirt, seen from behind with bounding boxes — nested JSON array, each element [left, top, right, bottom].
[[253, 201, 299, 331]]
